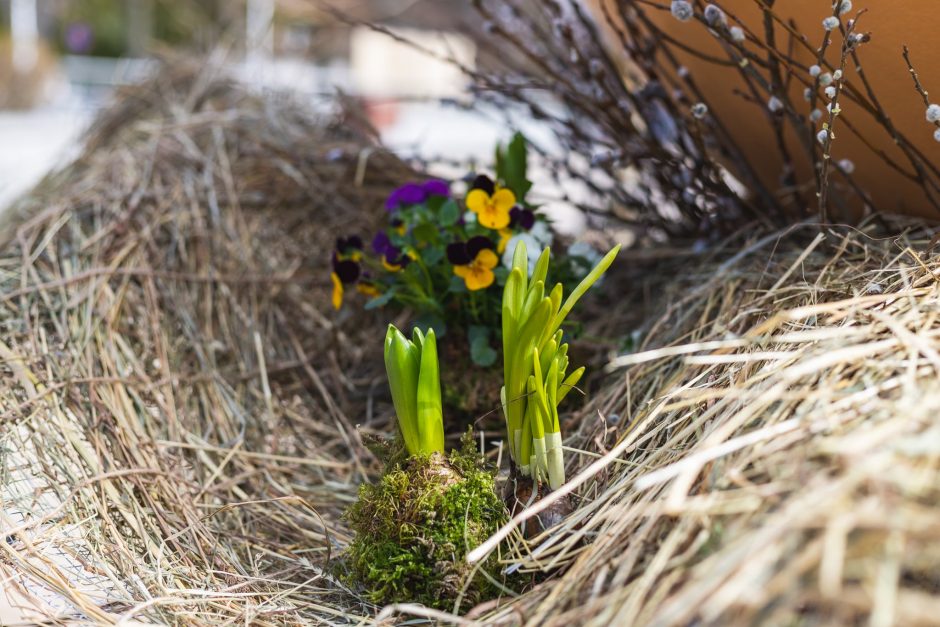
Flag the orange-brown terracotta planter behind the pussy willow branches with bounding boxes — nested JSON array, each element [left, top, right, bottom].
[[595, 0, 940, 217]]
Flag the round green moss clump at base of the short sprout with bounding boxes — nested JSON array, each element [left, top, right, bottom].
[[346, 437, 506, 609]]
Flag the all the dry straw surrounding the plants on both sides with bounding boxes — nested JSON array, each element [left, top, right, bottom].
[[0, 61, 940, 625]]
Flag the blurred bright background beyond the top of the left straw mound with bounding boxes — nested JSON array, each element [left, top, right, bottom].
[[0, 0, 578, 230]]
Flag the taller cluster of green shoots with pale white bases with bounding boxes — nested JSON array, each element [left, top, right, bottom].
[[500, 242, 620, 490]]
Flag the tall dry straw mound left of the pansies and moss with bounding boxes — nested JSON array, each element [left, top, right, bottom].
[[0, 60, 412, 625]]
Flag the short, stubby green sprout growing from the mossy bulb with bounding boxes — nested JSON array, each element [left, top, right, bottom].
[[385, 324, 444, 456]]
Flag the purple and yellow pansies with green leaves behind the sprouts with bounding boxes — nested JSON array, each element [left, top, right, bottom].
[[331, 136, 598, 365]]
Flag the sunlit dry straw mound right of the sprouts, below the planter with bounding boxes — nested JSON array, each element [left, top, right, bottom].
[[474, 222, 940, 625]]
